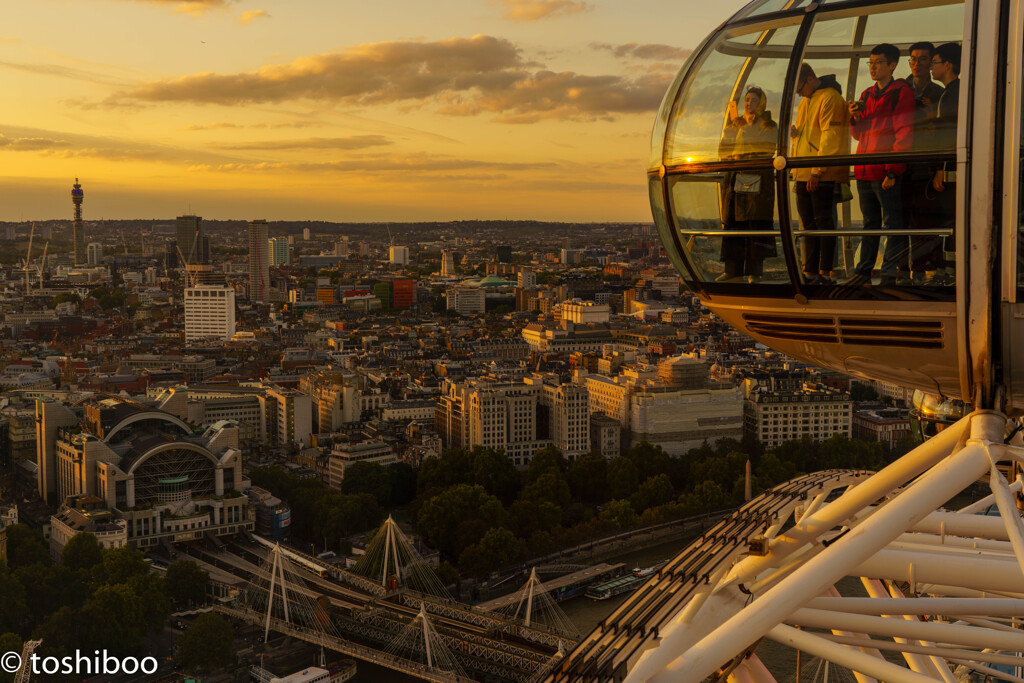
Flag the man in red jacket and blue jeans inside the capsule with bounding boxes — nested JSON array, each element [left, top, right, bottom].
[[849, 43, 914, 287]]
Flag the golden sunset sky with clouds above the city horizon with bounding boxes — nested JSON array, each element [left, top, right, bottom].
[[0, 0, 746, 221]]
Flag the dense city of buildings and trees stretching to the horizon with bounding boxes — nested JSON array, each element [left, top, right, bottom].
[[0, 179, 910, 680]]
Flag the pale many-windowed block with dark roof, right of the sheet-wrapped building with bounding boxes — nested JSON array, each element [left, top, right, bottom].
[[743, 379, 853, 449]]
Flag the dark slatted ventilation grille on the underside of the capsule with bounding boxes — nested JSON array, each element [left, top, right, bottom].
[[743, 313, 944, 349]]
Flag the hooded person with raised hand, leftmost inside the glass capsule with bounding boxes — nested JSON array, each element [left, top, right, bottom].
[[718, 85, 778, 282]]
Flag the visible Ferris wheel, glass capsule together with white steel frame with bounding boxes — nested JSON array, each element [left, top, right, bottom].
[[546, 0, 1024, 683]]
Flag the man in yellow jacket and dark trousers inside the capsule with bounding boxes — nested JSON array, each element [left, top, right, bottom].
[[790, 63, 850, 285]]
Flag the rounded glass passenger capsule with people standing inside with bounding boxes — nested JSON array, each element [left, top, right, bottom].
[[648, 0, 1024, 414]]
